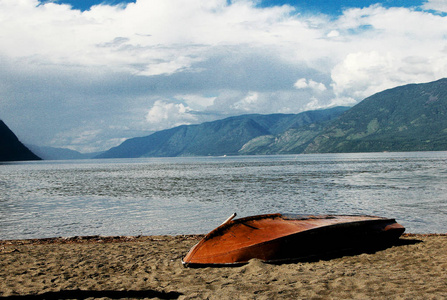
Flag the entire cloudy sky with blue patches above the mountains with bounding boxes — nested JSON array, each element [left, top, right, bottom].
[[0, 0, 447, 152]]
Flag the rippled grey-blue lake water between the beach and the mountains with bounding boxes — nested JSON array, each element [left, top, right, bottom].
[[0, 152, 447, 239]]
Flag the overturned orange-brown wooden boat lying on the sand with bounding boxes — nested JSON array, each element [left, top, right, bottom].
[[182, 214, 405, 267]]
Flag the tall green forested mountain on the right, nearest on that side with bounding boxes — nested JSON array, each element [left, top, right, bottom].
[[304, 79, 447, 153]]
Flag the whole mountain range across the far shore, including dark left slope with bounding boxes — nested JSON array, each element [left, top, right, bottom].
[[0, 78, 447, 161]]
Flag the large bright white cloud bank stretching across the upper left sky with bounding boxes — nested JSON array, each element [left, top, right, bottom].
[[0, 0, 300, 76]]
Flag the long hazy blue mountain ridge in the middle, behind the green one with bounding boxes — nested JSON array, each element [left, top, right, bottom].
[[98, 107, 348, 158]]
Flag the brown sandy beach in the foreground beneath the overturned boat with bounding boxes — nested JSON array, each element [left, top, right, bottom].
[[0, 235, 447, 299]]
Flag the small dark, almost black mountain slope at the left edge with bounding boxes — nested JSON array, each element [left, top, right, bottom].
[[0, 120, 40, 161]]
